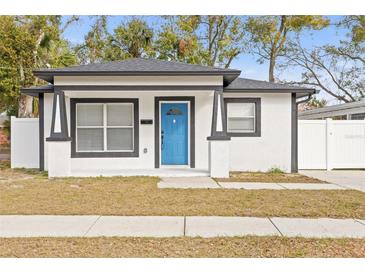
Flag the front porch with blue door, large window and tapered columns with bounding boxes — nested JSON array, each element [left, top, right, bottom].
[[45, 87, 230, 177]]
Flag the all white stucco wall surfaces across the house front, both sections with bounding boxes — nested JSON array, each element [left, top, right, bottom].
[[44, 76, 291, 171]]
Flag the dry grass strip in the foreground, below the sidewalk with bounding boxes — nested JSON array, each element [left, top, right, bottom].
[[0, 237, 365, 258]]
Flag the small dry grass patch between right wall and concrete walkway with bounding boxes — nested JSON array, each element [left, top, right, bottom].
[[216, 171, 326, 183]]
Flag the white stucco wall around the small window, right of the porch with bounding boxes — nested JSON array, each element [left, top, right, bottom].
[[224, 93, 291, 172]]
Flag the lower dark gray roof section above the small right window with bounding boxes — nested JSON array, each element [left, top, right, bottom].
[[224, 78, 314, 91]]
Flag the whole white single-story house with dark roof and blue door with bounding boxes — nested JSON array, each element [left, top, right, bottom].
[[22, 59, 315, 177]]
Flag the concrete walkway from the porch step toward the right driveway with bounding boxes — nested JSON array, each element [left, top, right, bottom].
[[157, 177, 345, 190]]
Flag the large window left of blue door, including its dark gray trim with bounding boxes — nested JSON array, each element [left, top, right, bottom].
[[71, 99, 138, 157]]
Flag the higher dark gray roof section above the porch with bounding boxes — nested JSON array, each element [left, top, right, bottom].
[[34, 58, 241, 85]]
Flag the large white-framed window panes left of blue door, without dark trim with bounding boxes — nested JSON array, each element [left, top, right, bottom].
[[75, 102, 135, 152]]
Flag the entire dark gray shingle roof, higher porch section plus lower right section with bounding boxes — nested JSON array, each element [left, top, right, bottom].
[[28, 58, 315, 97]]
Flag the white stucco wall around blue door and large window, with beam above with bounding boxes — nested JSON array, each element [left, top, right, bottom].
[[44, 76, 215, 171]]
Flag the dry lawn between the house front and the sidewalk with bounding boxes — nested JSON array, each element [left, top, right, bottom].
[[0, 162, 365, 219]]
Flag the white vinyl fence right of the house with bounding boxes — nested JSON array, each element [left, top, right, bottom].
[[298, 119, 365, 170]]
